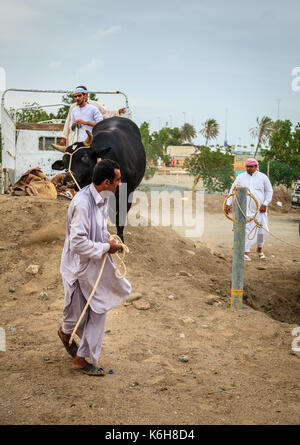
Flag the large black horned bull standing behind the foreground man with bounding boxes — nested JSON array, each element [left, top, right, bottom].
[[52, 117, 146, 240]]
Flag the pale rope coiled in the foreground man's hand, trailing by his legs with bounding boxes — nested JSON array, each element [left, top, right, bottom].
[[69, 233, 129, 346]]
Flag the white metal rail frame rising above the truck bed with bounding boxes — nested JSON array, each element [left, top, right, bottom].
[[1, 88, 130, 194]]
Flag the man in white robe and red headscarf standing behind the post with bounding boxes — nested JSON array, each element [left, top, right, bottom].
[[225, 158, 273, 261]]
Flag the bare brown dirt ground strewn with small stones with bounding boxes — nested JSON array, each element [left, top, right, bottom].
[[0, 187, 300, 425]]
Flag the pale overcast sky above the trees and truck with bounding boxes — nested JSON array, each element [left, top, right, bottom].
[[0, 0, 300, 145]]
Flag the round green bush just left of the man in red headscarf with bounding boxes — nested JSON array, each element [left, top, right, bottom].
[[184, 145, 235, 192]]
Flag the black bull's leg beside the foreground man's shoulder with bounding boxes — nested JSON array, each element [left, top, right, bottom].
[[109, 184, 133, 242]]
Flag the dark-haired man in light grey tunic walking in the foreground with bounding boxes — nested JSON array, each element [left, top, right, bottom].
[[58, 159, 131, 376]]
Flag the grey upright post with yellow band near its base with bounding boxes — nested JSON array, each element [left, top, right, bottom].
[[231, 187, 247, 309]]
